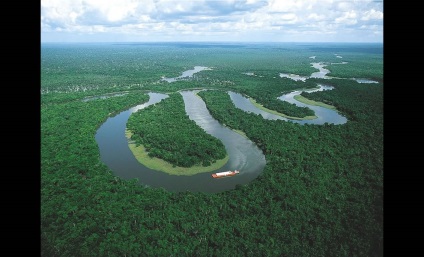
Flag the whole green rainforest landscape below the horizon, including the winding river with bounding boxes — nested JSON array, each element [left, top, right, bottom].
[[40, 42, 384, 257]]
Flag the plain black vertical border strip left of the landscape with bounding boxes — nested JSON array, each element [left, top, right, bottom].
[[1, 1, 41, 256]]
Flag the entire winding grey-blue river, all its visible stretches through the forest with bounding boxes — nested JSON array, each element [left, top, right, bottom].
[[95, 60, 375, 193]]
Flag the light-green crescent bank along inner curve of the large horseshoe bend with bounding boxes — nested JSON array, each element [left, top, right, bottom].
[[125, 129, 230, 176]]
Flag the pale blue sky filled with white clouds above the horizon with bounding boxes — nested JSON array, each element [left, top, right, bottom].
[[40, 0, 383, 43]]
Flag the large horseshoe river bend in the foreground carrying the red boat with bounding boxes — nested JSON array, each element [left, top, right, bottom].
[[96, 91, 266, 193]]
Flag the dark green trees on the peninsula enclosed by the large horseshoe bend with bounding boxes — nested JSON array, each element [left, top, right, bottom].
[[127, 94, 226, 167]]
